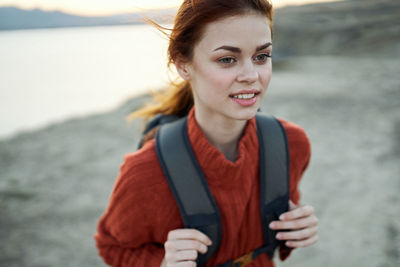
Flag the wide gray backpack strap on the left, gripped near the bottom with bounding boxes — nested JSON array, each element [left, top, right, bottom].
[[156, 117, 222, 266]]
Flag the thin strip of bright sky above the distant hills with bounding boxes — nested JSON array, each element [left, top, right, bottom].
[[0, 0, 337, 16]]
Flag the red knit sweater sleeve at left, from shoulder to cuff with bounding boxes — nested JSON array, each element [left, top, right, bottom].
[[95, 146, 170, 267]]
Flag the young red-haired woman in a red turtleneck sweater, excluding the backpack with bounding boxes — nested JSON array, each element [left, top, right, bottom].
[[95, 0, 318, 267]]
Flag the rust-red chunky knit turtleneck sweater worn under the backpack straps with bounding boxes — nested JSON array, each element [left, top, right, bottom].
[[95, 110, 310, 267]]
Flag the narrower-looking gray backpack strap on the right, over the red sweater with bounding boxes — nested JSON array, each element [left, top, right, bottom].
[[254, 113, 289, 258]]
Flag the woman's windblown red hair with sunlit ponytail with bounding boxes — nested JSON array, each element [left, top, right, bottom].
[[128, 0, 273, 119]]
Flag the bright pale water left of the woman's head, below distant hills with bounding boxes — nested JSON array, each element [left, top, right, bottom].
[[0, 25, 172, 138]]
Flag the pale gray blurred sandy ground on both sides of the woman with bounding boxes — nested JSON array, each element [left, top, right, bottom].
[[0, 56, 400, 267]]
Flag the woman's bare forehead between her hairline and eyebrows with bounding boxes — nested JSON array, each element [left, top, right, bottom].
[[197, 13, 272, 50]]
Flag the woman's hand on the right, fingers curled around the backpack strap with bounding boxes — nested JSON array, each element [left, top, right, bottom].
[[269, 201, 318, 248]]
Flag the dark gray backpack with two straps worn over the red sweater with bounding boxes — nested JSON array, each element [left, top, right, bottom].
[[139, 113, 289, 267]]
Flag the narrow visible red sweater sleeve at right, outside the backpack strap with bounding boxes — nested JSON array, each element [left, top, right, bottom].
[[279, 119, 311, 261]]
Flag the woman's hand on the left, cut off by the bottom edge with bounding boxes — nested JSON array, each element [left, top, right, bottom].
[[161, 229, 211, 267]]
